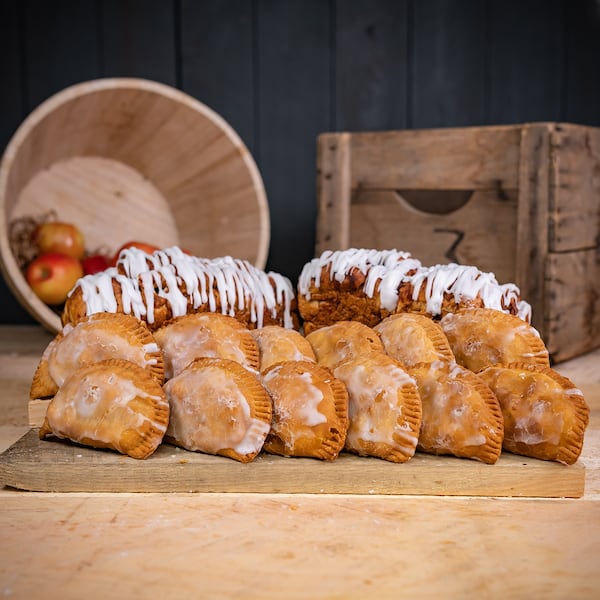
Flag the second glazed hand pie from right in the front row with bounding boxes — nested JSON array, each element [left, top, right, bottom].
[[410, 361, 504, 464]]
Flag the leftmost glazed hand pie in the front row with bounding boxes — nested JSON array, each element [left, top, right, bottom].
[[39, 359, 169, 458]]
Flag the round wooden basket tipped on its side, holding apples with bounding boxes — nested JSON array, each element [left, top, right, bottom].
[[0, 78, 270, 331]]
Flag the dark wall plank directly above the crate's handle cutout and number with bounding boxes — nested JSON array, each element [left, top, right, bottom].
[[409, 0, 487, 127]]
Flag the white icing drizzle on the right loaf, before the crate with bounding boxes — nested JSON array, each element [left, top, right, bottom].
[[298, 248, 531, 322]]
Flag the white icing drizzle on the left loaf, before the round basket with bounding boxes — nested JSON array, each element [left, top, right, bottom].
[[71, 246, 294, 328]]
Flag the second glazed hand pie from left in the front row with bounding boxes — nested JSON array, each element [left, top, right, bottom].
[[164, 357, 272, 463]]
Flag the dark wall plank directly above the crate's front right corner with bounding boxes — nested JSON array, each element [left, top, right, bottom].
[[487, 0, 572, 123]]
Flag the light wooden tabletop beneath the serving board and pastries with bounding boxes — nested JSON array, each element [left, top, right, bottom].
[[0, 326, 600, 599]]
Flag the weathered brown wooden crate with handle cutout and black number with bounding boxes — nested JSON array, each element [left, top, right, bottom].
[[316, 123, 600, 362]]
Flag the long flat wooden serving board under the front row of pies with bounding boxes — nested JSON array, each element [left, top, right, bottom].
[[0, 429, 585, 498]]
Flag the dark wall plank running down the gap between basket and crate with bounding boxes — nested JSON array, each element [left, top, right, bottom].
[[257, 0, 332, 280]]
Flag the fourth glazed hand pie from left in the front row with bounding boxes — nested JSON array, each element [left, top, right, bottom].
[[334, 352, 421, 463]]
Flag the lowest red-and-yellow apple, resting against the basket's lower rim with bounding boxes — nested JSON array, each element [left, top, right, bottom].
[[25, 252, 83, 305]]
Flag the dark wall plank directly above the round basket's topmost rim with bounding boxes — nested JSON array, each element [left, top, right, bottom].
[[99, 0, 177, 85]]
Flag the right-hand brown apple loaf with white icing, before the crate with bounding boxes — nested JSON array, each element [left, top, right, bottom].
[[297, 248, 531, 333]]
